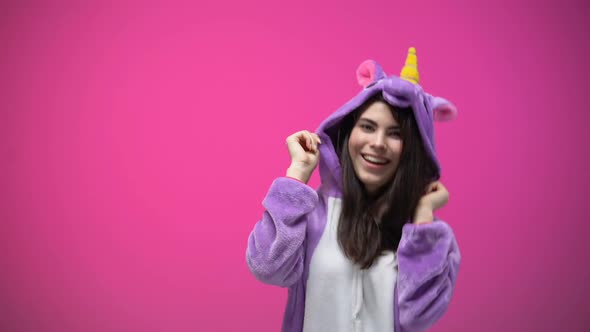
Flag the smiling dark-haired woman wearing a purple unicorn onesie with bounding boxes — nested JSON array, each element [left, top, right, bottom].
[[246, 48, 460, 332]]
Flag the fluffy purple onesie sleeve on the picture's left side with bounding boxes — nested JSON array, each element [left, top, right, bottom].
[[246, 178, 318, 287]]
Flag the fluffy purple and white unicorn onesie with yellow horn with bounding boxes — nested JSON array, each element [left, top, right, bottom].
[[246, 48, 461, 332]]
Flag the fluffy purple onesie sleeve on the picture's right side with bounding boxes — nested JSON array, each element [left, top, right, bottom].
[[396, 221, 461, 332]]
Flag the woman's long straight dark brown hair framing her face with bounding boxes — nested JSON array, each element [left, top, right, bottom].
[[336, 94, 438, 269]]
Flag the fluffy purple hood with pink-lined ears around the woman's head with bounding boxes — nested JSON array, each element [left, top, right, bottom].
[[316, 51, 457, 196]]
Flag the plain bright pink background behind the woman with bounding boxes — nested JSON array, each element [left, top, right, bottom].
[[0, 0, 590, 332]]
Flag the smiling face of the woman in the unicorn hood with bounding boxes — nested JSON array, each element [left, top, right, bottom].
[[348, 101, 403, 193]]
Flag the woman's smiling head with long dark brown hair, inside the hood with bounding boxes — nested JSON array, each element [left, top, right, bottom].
[[338, 94, 438, 268]]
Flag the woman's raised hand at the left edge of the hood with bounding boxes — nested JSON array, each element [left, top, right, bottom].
[[286, 130, 322, 183]]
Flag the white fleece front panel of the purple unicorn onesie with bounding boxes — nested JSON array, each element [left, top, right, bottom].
[[303, 198, 397, 332]]
